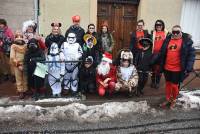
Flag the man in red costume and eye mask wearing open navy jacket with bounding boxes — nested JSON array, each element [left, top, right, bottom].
[[160, 25, 195, 109]]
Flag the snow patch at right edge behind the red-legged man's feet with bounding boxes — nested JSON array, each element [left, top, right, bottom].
[[177, 90, 200, 109]]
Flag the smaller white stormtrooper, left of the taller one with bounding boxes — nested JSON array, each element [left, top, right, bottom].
[[47, 42, 62, 96]]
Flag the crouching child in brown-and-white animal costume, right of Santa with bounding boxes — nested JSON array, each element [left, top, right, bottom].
[[115, 49, 138, 96]]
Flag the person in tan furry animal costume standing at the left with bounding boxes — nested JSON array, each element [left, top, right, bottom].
[[10, 32, 28, 99]]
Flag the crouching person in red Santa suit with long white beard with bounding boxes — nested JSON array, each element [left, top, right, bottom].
[[96, 52, 117, 96]]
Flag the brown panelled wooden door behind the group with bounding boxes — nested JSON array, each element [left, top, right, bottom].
[[97, 0, 137, 57]]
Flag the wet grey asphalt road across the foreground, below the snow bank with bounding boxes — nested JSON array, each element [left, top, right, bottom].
[[0, 105, 200, 134]]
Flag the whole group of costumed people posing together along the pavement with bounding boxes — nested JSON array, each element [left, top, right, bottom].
[[1, 15, 195, 107]]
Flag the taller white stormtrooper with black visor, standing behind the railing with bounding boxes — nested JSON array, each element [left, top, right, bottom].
[[60, 33, 83, 94]]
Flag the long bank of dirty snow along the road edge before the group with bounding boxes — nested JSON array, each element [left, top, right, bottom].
[[0, 101, 150, 122]]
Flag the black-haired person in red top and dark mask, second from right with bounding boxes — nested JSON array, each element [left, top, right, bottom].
[[151, 20, 168, 89]]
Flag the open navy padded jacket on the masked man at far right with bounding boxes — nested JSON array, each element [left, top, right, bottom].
[[159, 33, 195, 82]]
